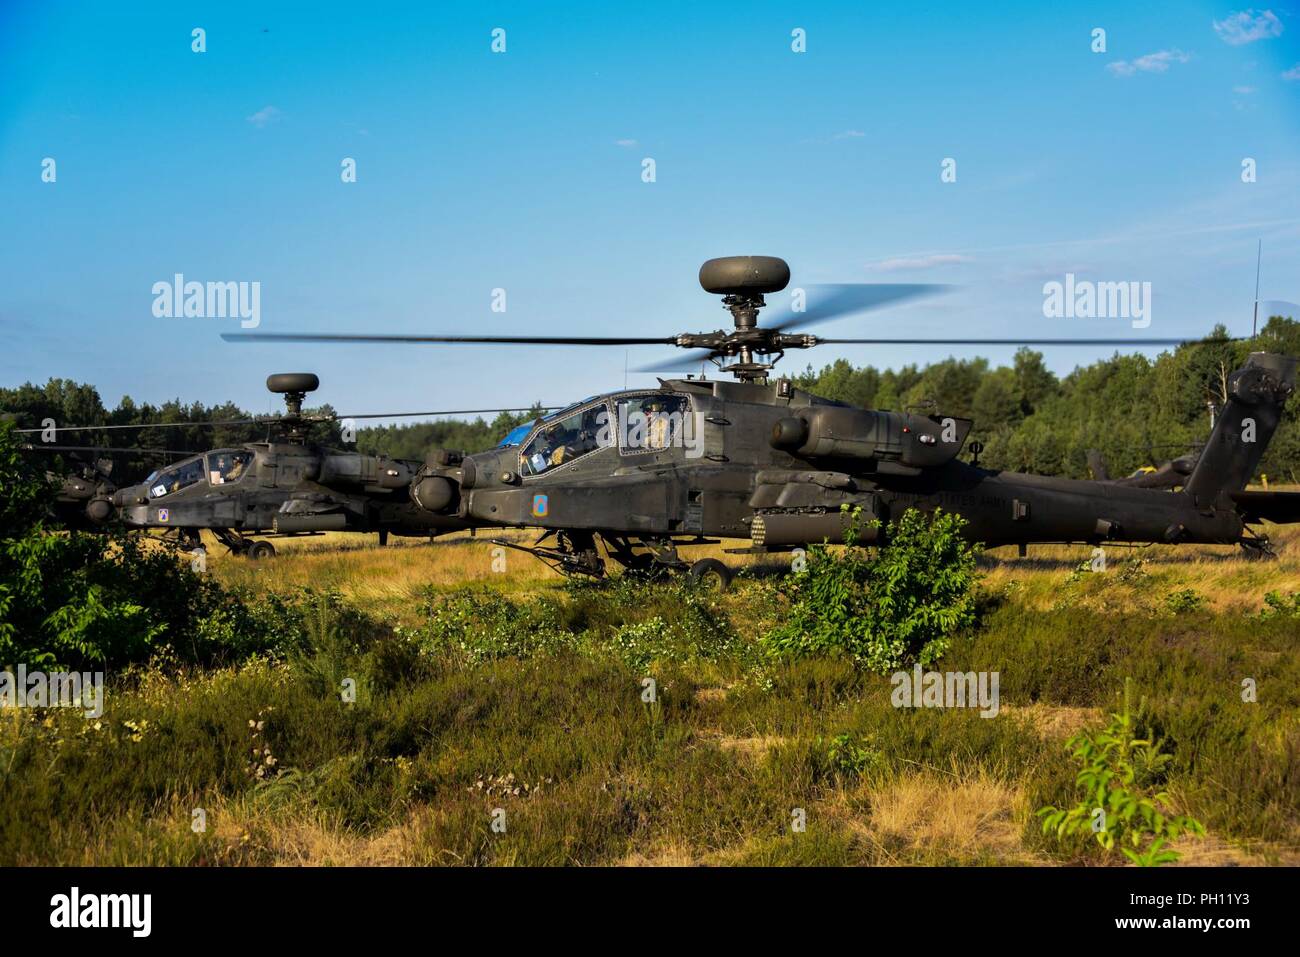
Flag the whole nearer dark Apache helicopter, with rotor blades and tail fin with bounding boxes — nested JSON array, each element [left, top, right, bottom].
[[224, 256, 1300, 586]]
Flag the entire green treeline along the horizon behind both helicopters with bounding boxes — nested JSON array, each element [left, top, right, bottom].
[[0, 316, 1300, 484]]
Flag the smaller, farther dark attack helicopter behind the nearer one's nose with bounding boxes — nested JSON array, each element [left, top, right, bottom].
[[26, 373, 543, 559]]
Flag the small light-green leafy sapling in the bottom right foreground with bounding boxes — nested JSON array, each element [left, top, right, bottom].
[[1039, 681, 1205, 867]]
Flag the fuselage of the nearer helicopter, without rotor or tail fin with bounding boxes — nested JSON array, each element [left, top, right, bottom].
[[413, 380, 1243, 549]]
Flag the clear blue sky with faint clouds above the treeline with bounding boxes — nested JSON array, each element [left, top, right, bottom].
[[0, 0, 1300, 421]]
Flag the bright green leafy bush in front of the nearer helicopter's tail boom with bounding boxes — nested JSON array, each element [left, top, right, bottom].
[[766, 508, 978, 674]]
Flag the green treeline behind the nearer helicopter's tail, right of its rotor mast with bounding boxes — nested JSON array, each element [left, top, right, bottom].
[[796, 316, 1300, 482]]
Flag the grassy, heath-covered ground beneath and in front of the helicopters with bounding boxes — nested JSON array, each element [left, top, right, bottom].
[[0, 531, 1300, 865]]
